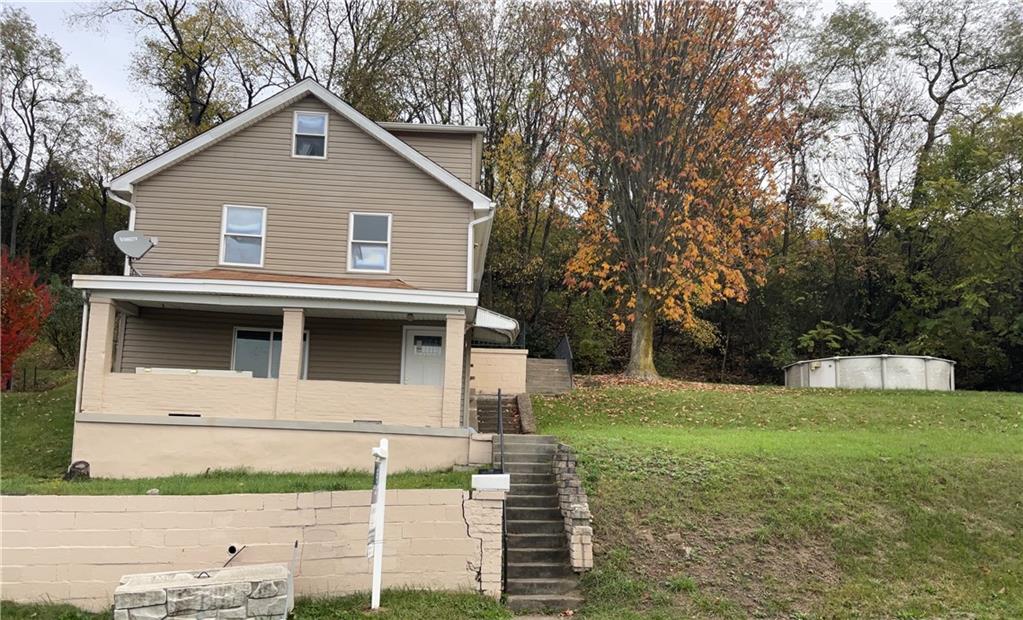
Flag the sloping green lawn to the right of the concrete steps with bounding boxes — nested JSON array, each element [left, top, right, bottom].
[[534, 383, 1023, 618]]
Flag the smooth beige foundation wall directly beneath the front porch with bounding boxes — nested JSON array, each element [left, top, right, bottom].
[[72, 422, 490, 478]]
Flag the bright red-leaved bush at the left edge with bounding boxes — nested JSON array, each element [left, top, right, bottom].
[[0, 248, 53, 387]]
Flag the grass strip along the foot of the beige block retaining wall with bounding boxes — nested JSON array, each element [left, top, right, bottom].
[[0, 589, 512, 620]]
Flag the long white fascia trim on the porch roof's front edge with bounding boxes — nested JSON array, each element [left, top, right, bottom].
[[73, 270, 478, 320]]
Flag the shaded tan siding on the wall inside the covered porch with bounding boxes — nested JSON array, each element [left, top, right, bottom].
[[120, 308, 419, 384]]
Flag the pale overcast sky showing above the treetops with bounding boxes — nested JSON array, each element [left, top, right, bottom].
[[9, 0, 895, 119]]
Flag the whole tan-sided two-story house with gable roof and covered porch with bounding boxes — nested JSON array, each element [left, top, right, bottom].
[[73, 80, 518, 477]]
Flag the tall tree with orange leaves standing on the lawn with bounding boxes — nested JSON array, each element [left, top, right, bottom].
[[567, 0, 786, 379]]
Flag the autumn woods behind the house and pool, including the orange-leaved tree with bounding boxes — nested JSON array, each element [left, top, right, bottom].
[[0, 0, 1023, 390]]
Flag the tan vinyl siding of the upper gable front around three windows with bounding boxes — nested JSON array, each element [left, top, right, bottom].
[[134, 97, 472, 291]]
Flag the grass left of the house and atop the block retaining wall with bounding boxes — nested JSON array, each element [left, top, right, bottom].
[[0, 381, 472, 495]]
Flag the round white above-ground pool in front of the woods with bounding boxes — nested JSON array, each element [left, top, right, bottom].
[[782, 355, 955, 392]]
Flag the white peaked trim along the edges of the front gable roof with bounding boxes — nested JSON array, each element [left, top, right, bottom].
[[109, 78, 492, 211]]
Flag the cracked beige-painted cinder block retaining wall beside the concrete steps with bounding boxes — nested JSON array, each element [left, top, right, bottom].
[[0, 489, 504, 610]]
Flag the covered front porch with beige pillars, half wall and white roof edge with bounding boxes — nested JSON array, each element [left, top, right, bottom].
[[76, 276, 475, 429]]
